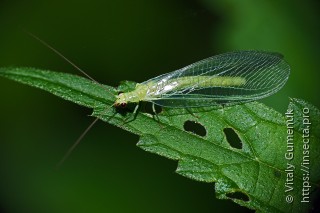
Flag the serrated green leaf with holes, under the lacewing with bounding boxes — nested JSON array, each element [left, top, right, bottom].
[[0, 68, 320, 212]]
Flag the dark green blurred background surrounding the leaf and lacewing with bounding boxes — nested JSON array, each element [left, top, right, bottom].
[[0, 0, 320, 213]]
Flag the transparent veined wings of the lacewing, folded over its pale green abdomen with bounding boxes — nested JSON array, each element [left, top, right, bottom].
[[142, 51, 290, 107]]
